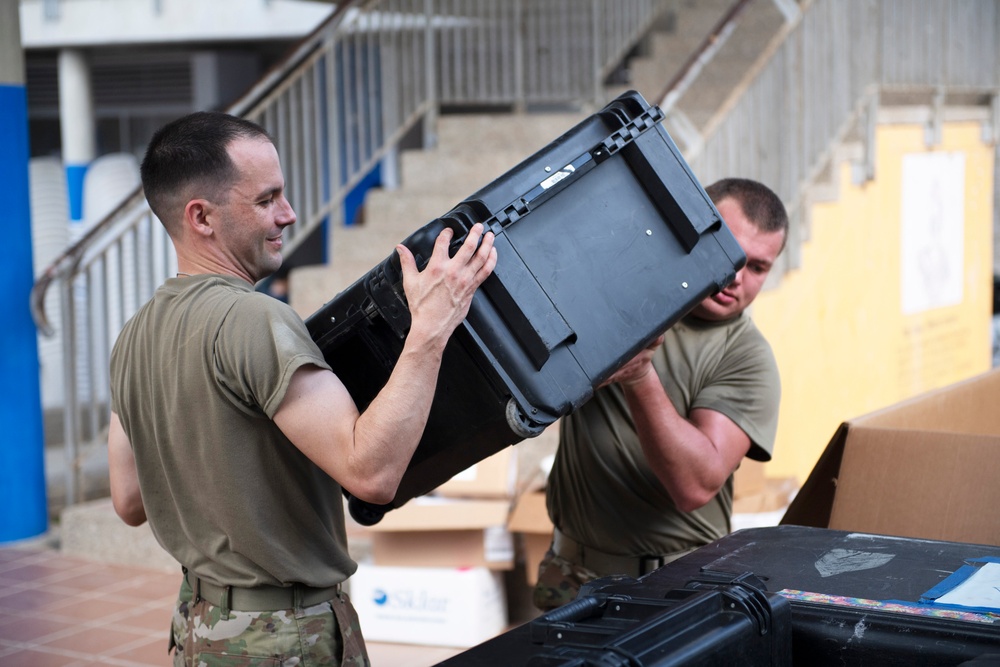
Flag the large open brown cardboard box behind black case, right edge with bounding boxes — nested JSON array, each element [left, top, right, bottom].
[[781, 369, 1000, 545]]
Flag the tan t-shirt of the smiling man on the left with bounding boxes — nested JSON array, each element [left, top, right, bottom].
[[111, 275, 357, 587]]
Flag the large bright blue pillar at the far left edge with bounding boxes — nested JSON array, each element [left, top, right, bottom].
[[0, 0, 48, 543]]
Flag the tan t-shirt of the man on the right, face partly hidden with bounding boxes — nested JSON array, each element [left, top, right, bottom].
[[547, 314, 780, 557]]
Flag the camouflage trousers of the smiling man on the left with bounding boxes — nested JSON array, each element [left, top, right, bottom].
[[170, 579, 371, 667]]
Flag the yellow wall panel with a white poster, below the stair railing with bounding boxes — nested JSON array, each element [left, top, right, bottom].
[[752, 122, 993, 482]]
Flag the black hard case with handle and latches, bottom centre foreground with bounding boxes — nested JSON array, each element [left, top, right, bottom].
[[516, 572, 792, 667]]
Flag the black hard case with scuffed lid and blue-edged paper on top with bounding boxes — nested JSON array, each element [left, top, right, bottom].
[[640, 525, 1000, 667]]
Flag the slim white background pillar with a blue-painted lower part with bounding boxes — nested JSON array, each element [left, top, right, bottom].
[[59, 49, 97, 222]]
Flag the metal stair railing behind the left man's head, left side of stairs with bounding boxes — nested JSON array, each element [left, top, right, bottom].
[[31, 0, 676, 504]]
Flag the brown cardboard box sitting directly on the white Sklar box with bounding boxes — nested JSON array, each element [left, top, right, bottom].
[[368, 496, 514, 570]]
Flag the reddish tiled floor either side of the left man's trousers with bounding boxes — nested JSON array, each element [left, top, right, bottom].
[[0, 546, 459, 667]]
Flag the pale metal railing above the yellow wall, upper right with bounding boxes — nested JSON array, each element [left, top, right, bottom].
[[688, 0, 1000, 277]]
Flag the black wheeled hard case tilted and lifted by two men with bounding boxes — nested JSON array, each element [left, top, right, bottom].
[[307, 92, 746, 524]]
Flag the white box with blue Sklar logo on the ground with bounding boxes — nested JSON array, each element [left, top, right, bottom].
[[348, 564, 507, 648]]
